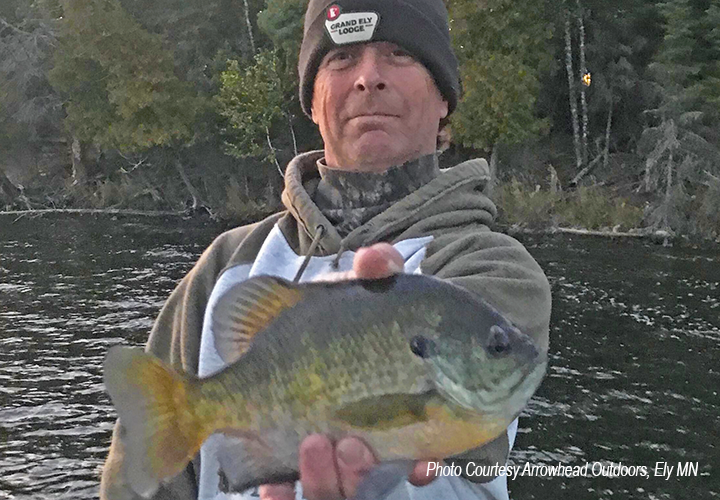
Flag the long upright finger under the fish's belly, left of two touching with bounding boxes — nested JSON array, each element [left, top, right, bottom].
[[300, 434, 342, 500]]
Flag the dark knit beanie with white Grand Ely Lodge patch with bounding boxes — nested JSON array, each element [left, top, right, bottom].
[[298, 0, 460, 116]]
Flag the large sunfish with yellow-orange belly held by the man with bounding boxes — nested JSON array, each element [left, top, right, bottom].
[[104, 274, 547, 497]]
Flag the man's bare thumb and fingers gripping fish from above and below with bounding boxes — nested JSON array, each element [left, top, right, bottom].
[[260, 243, 435, 500]]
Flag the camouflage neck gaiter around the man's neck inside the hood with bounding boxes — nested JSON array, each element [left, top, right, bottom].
[[314, 153, 439, 238]]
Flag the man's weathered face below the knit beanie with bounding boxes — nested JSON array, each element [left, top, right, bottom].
[[312, 42, 448, 172]]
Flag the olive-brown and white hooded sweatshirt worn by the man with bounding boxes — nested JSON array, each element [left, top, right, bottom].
[[101, 151, 551, 500]]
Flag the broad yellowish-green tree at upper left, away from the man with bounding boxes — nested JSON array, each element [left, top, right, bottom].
[[50, 0, 203, 151]]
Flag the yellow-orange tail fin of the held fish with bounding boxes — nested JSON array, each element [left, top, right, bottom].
[[104, 346, 206, 497]]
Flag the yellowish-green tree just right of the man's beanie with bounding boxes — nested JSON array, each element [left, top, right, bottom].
[[449, 0, 553, 150]]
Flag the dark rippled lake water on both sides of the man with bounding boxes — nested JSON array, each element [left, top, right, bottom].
[[0, 216, 720, 500]]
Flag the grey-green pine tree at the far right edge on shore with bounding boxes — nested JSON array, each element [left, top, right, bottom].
[[639, 0, 720, 232]]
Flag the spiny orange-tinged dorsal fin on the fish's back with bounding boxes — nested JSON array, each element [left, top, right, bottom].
[[212, 276, 303, 364]]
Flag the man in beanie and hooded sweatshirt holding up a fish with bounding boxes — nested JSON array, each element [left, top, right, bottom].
[[101, 0, 550, 500]]
